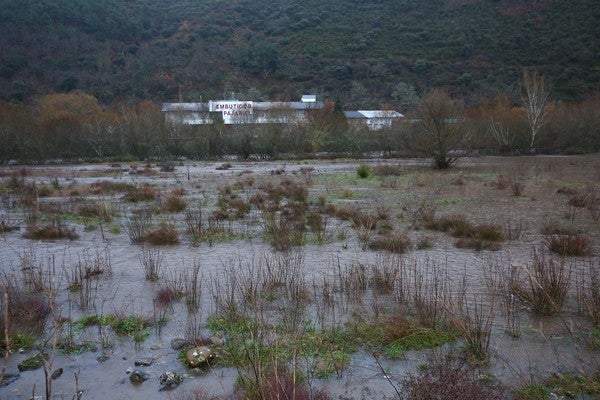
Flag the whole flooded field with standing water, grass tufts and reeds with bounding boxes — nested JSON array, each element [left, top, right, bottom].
[[0, 155, 600, 400]]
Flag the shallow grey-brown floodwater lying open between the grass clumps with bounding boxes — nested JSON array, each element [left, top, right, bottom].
[[0, 155, 600, 400]]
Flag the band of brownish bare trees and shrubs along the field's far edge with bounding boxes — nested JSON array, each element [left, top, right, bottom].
[[0, 83, 600, 168]]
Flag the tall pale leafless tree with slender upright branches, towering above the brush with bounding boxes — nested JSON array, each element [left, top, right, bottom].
[[520, 69, 550, 153]]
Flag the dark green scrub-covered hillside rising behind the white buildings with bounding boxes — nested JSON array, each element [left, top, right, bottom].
[[0, 0, 600, 111]]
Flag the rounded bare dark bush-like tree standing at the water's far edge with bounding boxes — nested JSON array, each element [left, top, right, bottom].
[[413, 89, 470, 169]]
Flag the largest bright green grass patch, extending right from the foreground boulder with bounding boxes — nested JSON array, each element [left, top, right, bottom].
[[206, 314, 456, 378]]
